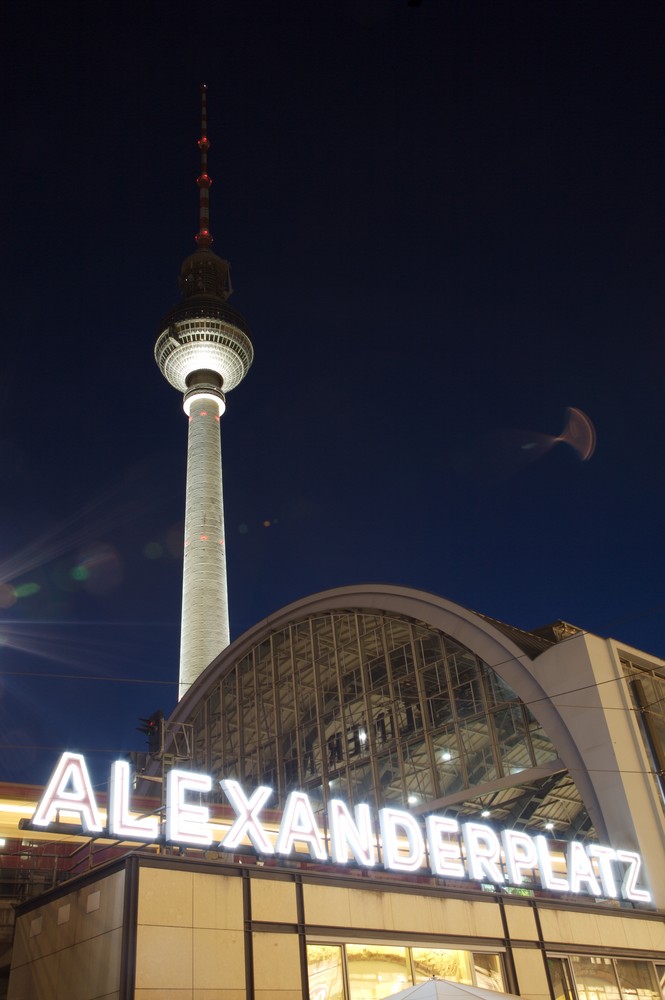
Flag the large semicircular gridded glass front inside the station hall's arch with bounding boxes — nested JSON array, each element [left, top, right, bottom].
[[179, 608, 594, 839]]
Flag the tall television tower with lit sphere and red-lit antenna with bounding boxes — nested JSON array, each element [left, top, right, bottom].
[[155, 84, 254, 698]]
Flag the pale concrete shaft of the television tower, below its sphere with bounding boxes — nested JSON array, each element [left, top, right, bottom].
[[179, 393, 230, 697]]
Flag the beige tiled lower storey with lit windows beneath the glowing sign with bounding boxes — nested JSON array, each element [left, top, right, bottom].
[[9, 854, 665, 1000]]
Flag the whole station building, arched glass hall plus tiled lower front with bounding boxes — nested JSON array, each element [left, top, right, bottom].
[[8, 586, 665, 1000]]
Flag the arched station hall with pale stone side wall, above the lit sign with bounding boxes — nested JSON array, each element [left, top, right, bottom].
[[173, 586, 665, 908]]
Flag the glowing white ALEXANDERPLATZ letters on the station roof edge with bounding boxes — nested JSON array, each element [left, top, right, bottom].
[[30, 752, 651, 903]]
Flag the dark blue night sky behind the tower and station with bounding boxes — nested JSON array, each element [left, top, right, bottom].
[[0, 0, 665, 788]]
